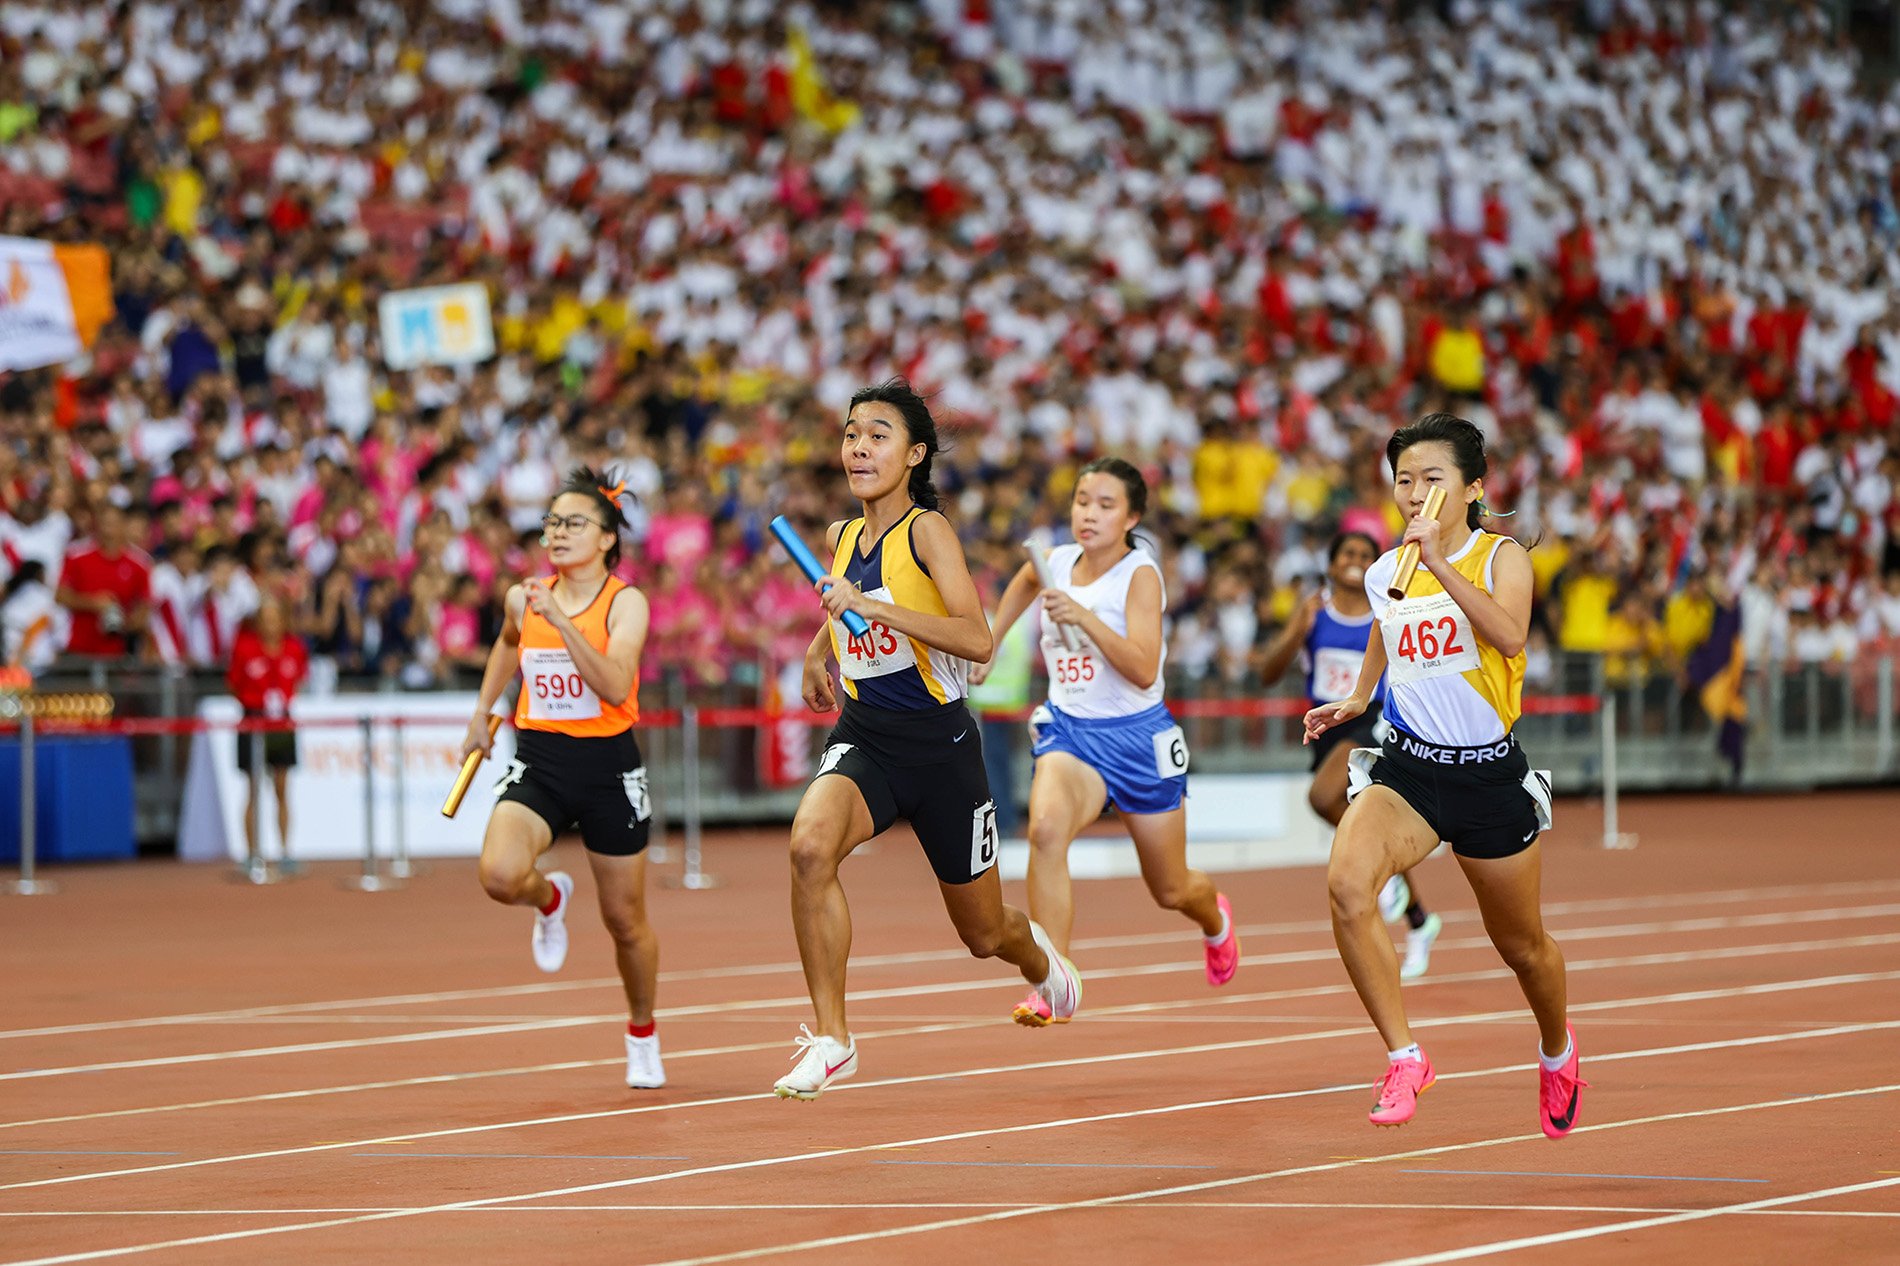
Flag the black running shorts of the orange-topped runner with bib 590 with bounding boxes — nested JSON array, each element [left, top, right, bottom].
[[494, 730, 654, 857]]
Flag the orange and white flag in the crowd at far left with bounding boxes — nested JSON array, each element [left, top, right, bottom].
[[0, 238, 112, 369]]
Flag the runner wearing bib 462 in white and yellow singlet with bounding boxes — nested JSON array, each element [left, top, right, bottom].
[[1305, 412, 1585, 1139]]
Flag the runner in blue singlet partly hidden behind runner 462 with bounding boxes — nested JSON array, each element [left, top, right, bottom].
[[1260, 532, 1444, 981]]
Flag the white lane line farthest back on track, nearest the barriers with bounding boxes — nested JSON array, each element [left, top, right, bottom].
[[0, 878, 1900, 1040]]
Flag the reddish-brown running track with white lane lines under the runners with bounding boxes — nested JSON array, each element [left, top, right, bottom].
[[0, 793, 1900, 1266]]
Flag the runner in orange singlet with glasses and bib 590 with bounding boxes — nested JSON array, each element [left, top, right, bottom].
[[464, 468, 667, 1089]]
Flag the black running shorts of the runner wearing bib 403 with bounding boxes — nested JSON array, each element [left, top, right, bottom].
[[817, 700, 998, 884]]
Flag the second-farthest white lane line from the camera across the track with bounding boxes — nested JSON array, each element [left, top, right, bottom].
[[14, 905, 1900, 1082]]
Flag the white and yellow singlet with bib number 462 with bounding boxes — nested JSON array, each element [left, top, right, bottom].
[[1366, 532, 1524, 747]]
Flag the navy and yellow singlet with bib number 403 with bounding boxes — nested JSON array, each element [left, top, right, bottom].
[[830, 506, 969, 713]]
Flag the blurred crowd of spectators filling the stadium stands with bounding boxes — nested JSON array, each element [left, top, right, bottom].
[[0, 0, 1900, 699]]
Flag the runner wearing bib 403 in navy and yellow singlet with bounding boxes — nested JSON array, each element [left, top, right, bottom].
[[773, 380, 1081, 1099]]
